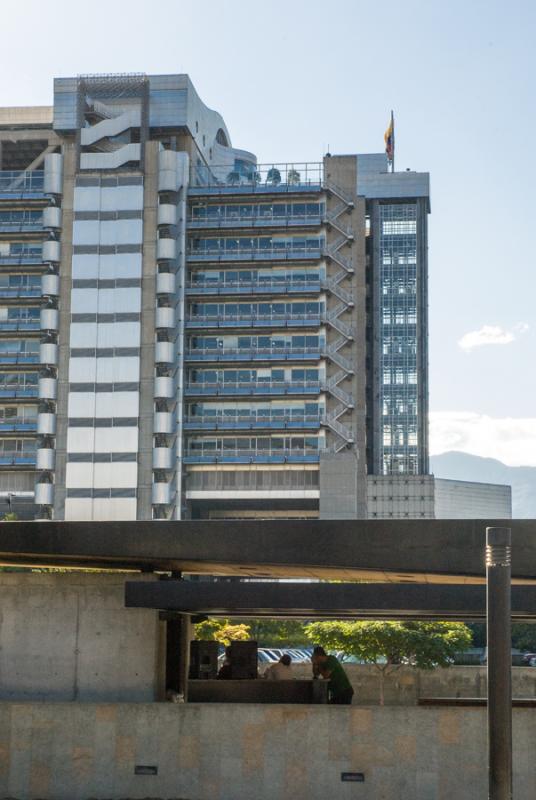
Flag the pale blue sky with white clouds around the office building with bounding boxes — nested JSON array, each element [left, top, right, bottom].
[[0, 0, 536, 465]]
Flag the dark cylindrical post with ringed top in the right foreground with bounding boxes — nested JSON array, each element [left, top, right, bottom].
[[486, 528, 512, 800]]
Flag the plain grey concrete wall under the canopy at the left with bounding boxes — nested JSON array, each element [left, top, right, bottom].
[[0, 572, 162, 700]]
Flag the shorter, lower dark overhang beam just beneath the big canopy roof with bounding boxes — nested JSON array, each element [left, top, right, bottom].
[[125, 580, 536, 622]]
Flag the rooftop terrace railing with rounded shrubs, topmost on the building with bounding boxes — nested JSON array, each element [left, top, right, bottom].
[[189, 162, 324, 195]]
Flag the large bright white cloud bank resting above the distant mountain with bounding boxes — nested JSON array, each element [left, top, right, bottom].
[[430, 411, 536, 466]]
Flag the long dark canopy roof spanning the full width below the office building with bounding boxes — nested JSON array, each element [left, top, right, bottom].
[[0, 520, 536, 584]]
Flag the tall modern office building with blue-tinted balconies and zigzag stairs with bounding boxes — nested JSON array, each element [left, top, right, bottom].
[[0, 74, 508, 520]]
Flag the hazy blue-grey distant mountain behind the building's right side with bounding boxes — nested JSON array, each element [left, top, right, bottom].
[[430, 450, 536, 519]]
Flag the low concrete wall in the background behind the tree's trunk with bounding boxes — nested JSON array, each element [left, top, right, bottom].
[[293, 664, 536, 704]]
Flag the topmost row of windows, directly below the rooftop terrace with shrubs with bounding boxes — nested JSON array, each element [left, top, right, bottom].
[[190, 203, 325, 222]]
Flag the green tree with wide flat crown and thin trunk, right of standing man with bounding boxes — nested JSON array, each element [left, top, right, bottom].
[[305, 622, 472, 706]]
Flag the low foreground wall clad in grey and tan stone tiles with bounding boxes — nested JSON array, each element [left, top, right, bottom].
[[0, 703, 536, 800]]
